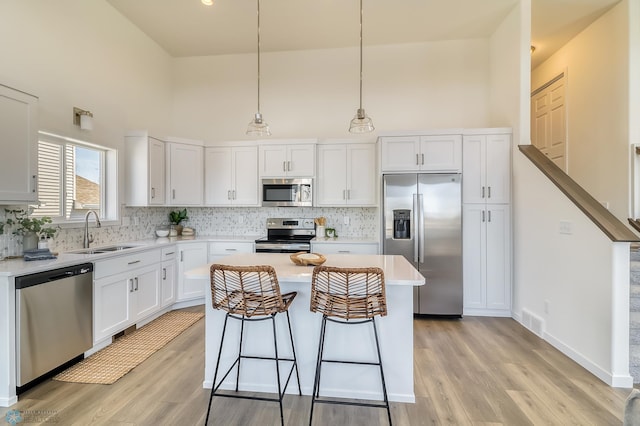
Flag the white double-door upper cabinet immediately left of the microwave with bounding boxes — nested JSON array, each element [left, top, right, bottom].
[[204, 145, 260, 207]]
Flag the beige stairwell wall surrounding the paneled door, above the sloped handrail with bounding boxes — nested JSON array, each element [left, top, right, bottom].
[[531, 0, 638, 223]]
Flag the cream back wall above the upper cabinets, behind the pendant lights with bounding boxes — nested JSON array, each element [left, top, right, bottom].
[[172, 39, 490, 141]]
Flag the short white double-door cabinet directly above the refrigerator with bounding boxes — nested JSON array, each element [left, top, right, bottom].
[[380, 134, 462, 173]]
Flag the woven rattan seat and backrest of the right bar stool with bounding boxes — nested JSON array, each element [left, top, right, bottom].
[[310, 265, 387, 319]]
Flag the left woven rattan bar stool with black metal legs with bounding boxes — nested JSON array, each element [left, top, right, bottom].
[[205, 264, 302, 425]]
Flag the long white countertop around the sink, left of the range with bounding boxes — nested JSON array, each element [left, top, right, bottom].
[[0, 235, 261, 276]]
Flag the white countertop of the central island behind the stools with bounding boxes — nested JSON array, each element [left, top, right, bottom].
[[186, 253, 425, 286]]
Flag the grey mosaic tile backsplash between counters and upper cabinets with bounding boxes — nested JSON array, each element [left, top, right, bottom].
[[0, 207, 380, 255]]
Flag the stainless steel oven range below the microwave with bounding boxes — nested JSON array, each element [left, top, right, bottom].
[[256, 218, 316, 253]]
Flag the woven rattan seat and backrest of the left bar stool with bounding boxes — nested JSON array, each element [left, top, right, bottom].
[[211, 264, 286, 317]]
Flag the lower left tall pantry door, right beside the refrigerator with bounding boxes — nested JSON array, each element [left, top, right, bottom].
[[462, 204, 487, 309]]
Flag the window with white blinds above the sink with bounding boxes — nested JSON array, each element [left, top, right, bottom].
[[33, 132, 116, 222]]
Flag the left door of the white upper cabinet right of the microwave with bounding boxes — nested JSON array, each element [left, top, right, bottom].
[[315, 145, 347, 206]]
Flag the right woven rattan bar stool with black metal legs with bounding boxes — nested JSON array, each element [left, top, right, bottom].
[[309, 266, 392, 425]]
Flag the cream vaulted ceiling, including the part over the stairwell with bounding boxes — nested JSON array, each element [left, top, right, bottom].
[[107, 0, 620, 67]]
